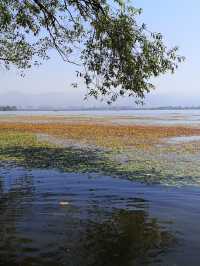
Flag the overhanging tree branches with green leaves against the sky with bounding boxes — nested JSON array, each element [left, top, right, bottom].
[[0, 0, 184, 103]]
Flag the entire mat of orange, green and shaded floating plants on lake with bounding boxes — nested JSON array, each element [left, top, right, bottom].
[[0, 117, 200, 185]]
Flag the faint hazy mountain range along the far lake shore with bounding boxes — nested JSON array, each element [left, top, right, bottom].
[[0, 91, 200, 110]]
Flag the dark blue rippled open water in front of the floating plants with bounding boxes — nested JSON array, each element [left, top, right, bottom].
[[0, 166, 200, 266]]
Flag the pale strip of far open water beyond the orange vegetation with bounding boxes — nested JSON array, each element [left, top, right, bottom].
[[0, 110, 200, 126]]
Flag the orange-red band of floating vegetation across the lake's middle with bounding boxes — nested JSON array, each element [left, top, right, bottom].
[[0, 117, 200, 149]]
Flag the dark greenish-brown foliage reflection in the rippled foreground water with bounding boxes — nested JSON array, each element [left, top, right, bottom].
[[77, 210, 174, 266]]
